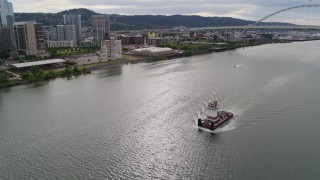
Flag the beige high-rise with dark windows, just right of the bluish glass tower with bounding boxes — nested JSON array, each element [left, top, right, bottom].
[[13, 21, 45, 55]]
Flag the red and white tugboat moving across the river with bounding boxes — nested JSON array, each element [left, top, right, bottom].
[[198, 101, 233, 131]]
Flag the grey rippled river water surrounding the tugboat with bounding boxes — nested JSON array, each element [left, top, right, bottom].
[[0, 41, 320, 180]]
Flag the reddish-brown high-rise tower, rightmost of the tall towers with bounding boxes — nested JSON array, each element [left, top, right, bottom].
[[92, 15, 110, 42]]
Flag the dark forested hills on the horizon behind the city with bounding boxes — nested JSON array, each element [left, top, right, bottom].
[[15, 8, 290, 30]]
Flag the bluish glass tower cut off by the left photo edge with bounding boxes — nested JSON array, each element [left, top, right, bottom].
[[0, 0, 14, 51]]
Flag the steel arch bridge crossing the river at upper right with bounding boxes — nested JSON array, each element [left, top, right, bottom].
[[192, 4, 320, 41]]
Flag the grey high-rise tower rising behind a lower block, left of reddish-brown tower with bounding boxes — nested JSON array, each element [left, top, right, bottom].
[[63, 14, 82, 44]]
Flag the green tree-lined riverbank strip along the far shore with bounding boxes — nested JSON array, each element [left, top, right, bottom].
[[0, 41, 310, 88]]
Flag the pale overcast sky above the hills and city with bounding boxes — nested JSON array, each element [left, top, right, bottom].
[[8, 0, 320, 20]]
